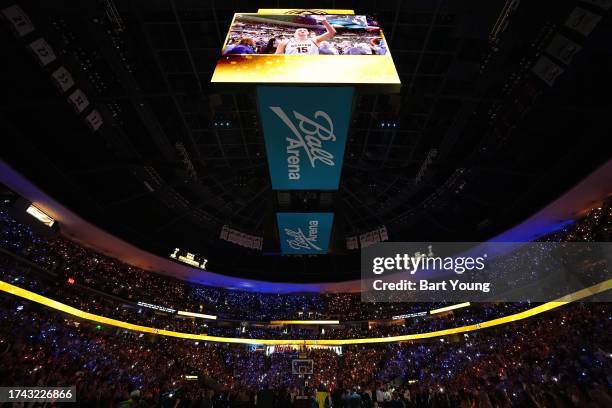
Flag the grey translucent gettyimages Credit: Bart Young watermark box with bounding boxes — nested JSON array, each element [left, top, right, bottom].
[[361, 242, 612, 302]]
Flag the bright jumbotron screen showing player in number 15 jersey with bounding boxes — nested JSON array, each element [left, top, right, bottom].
[[211, 13, 400, 85]]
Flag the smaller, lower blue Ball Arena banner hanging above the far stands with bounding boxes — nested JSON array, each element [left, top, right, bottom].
[[276, 213, 334, 254]]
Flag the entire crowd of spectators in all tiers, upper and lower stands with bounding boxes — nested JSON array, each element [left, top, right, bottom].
[[0, 200, 612, 407]]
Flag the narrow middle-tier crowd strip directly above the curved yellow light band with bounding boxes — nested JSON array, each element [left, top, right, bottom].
[[0, 253, 533, 339]]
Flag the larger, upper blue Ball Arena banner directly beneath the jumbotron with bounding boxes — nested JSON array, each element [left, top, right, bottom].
[[257, 86, 354, 190]]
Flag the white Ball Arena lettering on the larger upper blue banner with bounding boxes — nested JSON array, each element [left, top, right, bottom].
[[270, 106, 336, 180]]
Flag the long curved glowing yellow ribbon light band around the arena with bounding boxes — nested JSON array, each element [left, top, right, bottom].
[[0, 279, 612, 346]]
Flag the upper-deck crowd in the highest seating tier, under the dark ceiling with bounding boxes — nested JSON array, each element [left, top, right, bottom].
[[0, 198, 612, 321]]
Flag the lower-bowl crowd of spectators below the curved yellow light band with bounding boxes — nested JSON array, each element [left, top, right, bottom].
[[0, 296, 612, 407]]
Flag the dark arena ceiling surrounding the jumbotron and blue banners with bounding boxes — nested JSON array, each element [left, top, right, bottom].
[[0, 0, 612, 282]]
